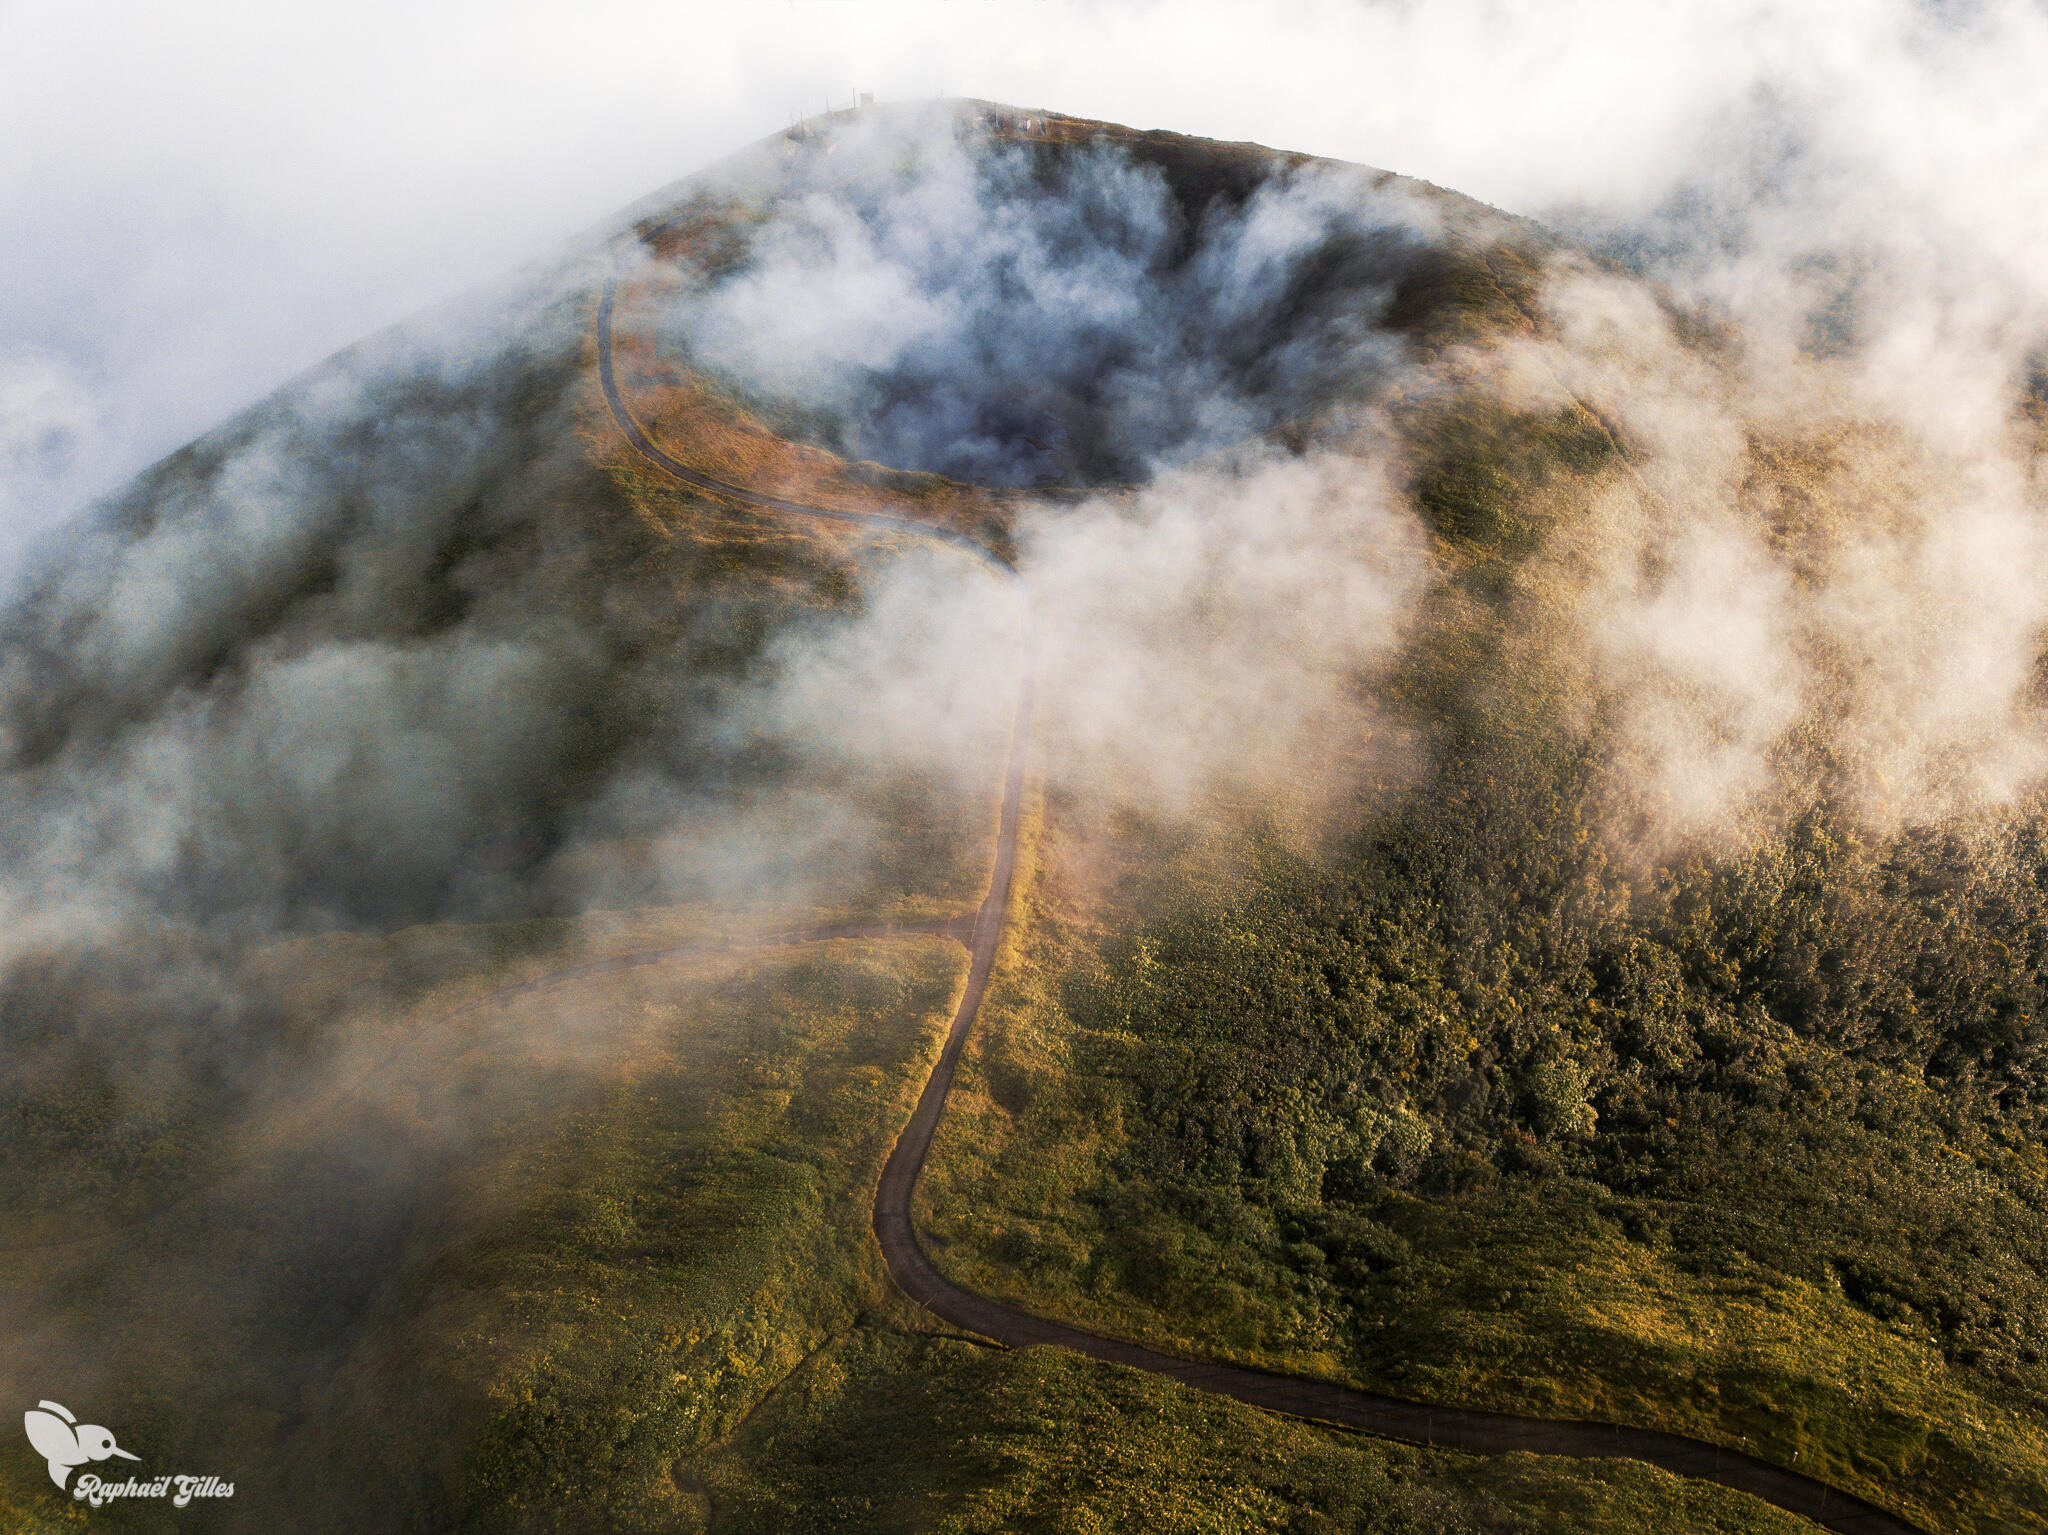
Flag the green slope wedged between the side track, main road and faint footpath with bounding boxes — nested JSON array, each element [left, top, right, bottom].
[[0, 939, 965, 1529]]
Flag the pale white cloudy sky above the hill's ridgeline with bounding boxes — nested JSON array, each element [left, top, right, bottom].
[[0, 0, 2048, 569]]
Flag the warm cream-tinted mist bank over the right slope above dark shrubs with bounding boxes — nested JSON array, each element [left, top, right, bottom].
[[1536, 250, 2048, 858]]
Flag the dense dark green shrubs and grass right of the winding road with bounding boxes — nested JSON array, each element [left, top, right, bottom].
[[924, 392, 2048, 1531]]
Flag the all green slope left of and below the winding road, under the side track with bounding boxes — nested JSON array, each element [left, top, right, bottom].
[[0, 912, 1826, 1535]]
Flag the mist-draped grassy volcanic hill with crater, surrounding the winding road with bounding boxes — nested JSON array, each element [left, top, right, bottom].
[[0, 99, 2048, 1535]]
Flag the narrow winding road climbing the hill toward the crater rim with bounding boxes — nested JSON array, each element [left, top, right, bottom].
[[598, 258, 1925, 1535]]
